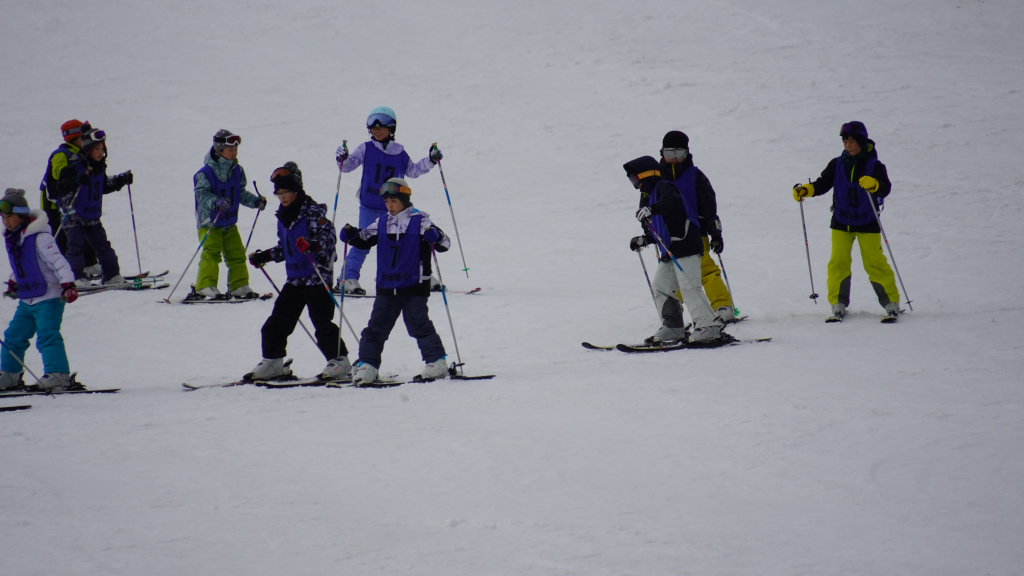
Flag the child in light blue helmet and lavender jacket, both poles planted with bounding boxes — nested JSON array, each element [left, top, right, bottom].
[[336, 106, 443, 294]]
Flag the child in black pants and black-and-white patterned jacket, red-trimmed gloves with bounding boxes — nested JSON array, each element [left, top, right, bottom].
[[244, 162, 352, 381]]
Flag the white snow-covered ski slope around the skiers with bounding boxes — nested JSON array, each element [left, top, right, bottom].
[[0, 0, 1024, 576]]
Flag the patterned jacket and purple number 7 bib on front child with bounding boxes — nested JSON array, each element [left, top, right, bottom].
[[342, 206, 452, 296]]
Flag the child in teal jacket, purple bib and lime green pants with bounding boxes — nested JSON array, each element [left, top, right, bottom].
[[185, 129, 266, 300]]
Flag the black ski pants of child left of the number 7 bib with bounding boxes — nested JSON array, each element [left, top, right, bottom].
[[261, 283, 348, 360]]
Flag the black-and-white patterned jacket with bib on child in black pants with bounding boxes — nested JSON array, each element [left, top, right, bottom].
[[270, 195, 338, 286]]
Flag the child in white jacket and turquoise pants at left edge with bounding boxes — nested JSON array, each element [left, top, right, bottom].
[[0, 189, 78, 392]]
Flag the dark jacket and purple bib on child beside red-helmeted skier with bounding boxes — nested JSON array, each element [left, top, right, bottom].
[[57, 152, 122, 229]]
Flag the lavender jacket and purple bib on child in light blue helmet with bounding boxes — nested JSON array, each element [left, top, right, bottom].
[[338, 139, 434, 210]]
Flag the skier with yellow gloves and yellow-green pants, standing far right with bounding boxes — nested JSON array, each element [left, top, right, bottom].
[[793, 121, 900, 322]]
